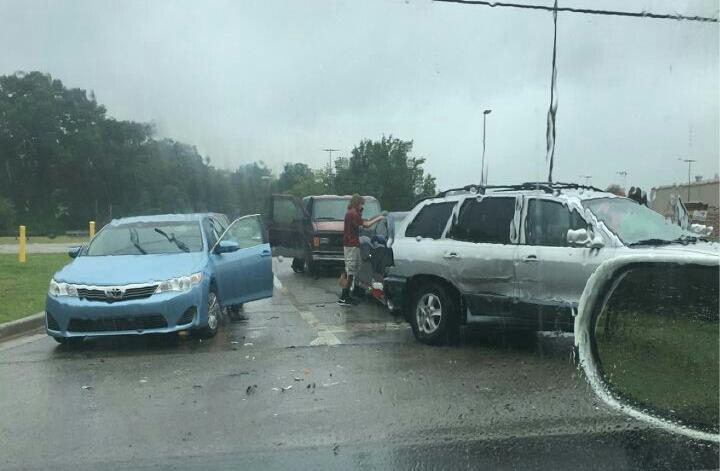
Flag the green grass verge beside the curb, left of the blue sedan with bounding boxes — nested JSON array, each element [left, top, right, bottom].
[[0, 253, 71, 323]]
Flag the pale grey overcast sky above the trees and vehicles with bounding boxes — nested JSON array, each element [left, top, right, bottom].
[[0, 0, 720, 192]]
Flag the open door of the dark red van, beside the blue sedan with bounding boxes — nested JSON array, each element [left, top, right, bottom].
[[266, 195, 311, 258]]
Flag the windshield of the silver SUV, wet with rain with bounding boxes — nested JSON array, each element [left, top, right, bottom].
[[583, 198, 697, 245]]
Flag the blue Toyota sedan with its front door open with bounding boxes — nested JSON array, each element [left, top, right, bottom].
[[45, 214, 273, 343]]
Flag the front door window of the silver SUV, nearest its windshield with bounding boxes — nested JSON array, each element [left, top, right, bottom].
[[525, 199, 587, 247]]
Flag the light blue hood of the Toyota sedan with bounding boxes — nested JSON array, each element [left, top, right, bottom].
[[54, 252, 207, 286]]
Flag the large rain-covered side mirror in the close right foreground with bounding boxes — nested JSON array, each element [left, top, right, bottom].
[[575, 254, 720, 441]]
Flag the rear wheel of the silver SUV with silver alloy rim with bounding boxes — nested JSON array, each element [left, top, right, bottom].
[[409, 282, 460, 345]]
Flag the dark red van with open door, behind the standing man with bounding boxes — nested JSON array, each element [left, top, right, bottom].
[[266, 195, 381, 273]]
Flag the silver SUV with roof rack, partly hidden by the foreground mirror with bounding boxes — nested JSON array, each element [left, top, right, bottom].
[[383, 183, 719, 344]]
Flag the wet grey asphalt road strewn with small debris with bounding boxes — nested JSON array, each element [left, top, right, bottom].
[[0, 261, 718, 470]]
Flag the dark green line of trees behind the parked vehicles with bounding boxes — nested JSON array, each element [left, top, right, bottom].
[[0, 72, 435, 235]]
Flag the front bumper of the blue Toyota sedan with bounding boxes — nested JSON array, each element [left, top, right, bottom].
[[45, 283, 208, 337]]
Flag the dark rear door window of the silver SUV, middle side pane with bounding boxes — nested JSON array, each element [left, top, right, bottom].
[[450, 197, 515, 244]]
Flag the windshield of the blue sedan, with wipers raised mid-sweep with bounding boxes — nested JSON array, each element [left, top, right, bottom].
[[87, 222, 203, 257]]
